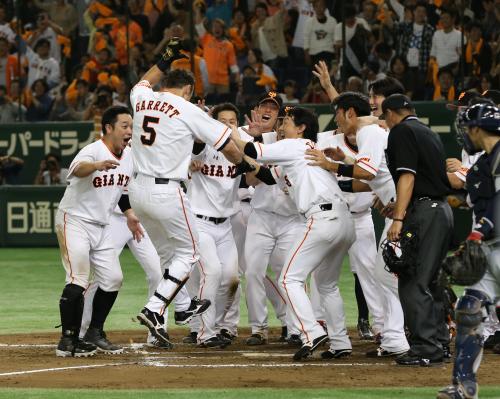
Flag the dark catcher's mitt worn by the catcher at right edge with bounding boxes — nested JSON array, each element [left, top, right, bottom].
[[443, 240, 488, 286]]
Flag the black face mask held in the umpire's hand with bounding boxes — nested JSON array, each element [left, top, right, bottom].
[[380, 227, 418, 277]]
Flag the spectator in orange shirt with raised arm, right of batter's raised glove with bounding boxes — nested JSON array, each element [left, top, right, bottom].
[[196, 14, 239, 102]]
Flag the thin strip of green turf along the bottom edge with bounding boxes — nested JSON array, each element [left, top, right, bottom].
[[0, 387, 500, 399]]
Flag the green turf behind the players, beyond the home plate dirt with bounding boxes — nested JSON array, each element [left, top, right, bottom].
[[0, 248, 357, 334]]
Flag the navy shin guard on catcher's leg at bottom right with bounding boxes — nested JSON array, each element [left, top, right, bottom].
[[453, 289, 489, 397]]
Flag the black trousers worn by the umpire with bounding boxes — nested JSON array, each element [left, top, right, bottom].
[[399, 198, 453, 359]]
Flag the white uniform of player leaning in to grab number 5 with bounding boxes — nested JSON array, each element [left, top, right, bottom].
[[248, 139, 354, 347]]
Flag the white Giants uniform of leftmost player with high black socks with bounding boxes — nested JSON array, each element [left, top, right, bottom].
[[56, 140, 132, 292]]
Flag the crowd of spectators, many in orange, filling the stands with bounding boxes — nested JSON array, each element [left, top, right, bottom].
[[0, 0, 500, 123]]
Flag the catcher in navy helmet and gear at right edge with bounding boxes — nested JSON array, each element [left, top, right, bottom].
[[437, 103, 500, 399]]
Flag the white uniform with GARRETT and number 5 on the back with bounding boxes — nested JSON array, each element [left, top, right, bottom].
[[129, 80, 231, 314]]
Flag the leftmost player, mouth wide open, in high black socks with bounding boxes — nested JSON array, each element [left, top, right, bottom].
[[56, 107, 142, 357]]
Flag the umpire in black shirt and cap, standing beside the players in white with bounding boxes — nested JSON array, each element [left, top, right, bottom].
[[380, 94, 453, 366]]
